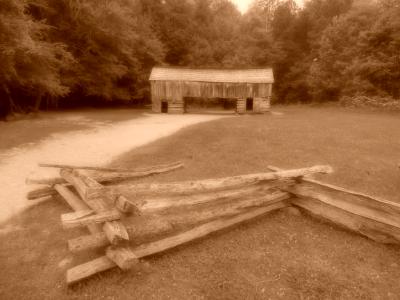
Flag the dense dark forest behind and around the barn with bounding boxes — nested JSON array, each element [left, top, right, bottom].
[[0, 0, 400, 116]]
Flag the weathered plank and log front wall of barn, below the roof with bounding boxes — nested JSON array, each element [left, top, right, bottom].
[[151, 81, 272, 113]]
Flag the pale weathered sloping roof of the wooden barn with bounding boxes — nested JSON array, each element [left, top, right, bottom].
[[149, 67, 274, 83]]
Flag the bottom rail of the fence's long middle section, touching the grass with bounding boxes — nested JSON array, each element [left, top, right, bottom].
[[67, 203, 288, 285]]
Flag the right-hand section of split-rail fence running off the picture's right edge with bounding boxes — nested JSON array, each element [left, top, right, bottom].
[[271, 167, 400, 244]]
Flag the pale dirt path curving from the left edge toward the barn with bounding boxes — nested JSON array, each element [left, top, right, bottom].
[[0, 114, 225, 222]]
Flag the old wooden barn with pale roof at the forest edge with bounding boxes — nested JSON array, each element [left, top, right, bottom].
[[149, 67, 274, 114]]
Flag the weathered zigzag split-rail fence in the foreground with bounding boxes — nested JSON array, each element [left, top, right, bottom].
[[25, 163, 400, 285]]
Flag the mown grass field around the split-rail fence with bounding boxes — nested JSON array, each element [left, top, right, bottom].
[[0, 106, 400, 299]]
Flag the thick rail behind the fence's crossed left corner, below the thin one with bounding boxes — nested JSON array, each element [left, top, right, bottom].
[[26, 162, 184, 185]]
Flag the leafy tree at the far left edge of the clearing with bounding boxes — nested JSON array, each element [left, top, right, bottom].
[[0, 0, 74, 115]]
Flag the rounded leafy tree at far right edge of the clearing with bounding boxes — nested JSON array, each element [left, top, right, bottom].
[[310, 2, 400, 100]]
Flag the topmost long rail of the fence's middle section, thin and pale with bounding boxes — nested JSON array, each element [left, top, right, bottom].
[[111, 166, 332, 199]]
